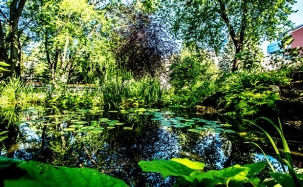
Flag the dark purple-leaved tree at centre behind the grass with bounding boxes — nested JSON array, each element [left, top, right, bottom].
[[115, 6, 178, 78]]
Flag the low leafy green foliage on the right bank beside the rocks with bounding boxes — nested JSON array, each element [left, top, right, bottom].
[[217, 71, 290, 116]]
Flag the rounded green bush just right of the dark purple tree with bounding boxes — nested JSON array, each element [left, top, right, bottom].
[[169, 48, 218, 107]]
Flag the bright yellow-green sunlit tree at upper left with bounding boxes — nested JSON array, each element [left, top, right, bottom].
[[27, 0, 113, 84]]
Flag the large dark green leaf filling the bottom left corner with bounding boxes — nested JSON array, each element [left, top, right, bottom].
[[0, 157, 127, 187]]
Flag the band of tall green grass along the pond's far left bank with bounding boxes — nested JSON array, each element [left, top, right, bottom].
[[0, 70, 163, 109]]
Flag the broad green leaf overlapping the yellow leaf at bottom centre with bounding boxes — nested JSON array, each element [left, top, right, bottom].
[[138, 160, 195, 182]]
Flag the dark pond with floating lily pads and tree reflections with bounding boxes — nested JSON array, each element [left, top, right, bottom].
[[1, 106, 303, 186]]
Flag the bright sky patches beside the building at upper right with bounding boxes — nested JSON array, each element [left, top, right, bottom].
[[261, 0, 303, 55]]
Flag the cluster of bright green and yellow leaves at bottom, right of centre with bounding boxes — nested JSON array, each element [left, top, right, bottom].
[[139, 158, 265, 187]]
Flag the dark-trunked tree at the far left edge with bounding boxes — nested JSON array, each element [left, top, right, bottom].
[[0, 0, 26, 76]]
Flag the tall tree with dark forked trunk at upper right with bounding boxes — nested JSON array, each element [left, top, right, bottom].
[[159, 0, 296, 71]]
